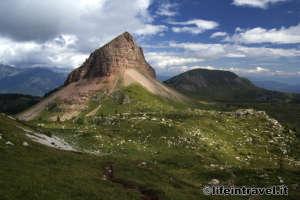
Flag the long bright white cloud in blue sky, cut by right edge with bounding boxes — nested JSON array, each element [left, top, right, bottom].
[[225, 24, 300, 44]]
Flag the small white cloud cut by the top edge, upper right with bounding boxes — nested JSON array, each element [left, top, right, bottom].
[[233, 0, 288, 9]]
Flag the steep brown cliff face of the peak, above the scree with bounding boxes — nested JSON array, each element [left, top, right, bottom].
[[65, 32, 155, 85]]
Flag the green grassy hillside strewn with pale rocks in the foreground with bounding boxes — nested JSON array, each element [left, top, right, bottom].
[[0, 85, 300, 200]]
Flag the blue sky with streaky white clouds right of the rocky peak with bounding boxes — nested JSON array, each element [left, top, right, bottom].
[[143, 0, 300, 82]]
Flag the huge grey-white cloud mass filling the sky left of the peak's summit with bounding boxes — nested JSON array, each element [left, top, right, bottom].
[[0, 0, 167, 67]]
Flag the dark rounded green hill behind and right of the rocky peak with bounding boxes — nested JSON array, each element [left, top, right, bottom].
[[165, 69, 300, 103]]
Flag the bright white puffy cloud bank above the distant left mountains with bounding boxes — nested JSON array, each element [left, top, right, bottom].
[[0, 35, 88, 68]]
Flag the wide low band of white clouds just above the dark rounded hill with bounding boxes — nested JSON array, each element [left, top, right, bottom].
[[145, 41, 300, 75]]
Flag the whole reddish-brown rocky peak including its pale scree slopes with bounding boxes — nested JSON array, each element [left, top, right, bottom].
[[18, 32, 187, 121]]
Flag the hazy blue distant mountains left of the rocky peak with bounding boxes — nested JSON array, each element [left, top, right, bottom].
[[0, 65, 66, 96]]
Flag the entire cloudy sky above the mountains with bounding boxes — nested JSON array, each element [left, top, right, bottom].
[[0, 0, 300, 82]]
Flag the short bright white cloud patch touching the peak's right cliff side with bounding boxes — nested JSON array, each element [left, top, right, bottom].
[[145, 52, 203, 68]]
